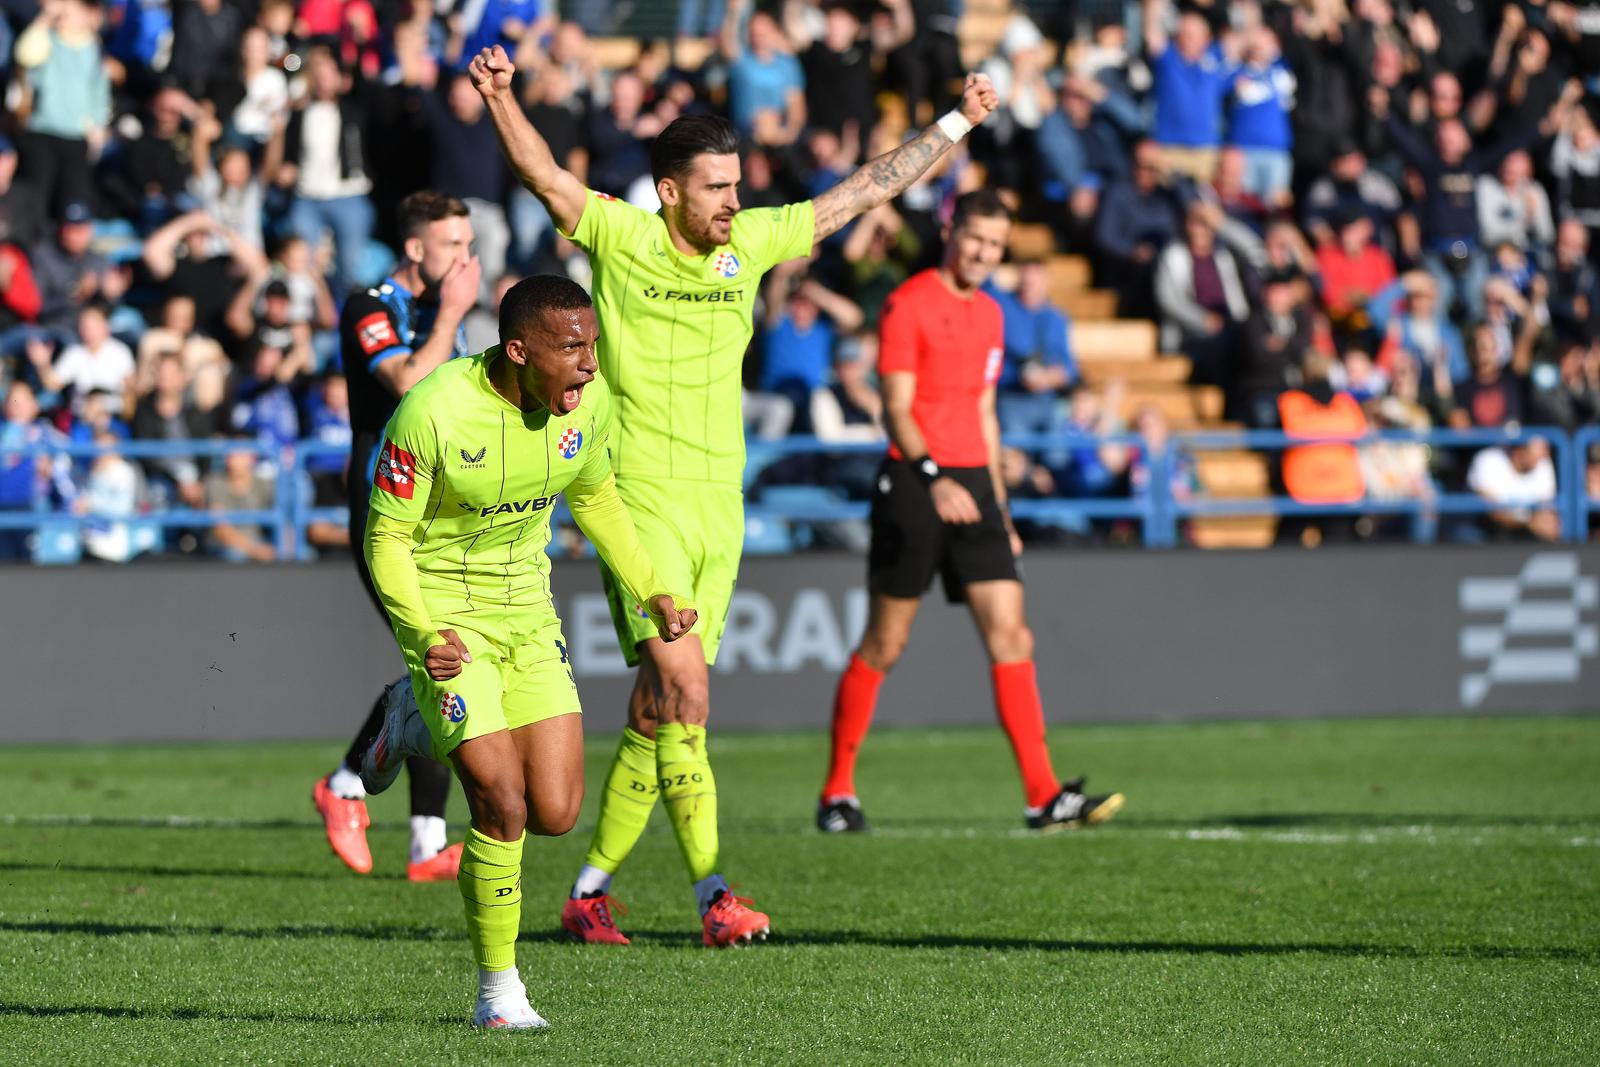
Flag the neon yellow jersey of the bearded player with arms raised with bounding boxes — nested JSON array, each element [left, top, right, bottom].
[[568, 190, 816, 486]]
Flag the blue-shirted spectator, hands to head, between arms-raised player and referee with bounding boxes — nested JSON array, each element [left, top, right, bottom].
[[762, 272, 862, 434]]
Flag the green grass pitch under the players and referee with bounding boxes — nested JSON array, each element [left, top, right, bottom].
[[0, 717, 1600, 1067]]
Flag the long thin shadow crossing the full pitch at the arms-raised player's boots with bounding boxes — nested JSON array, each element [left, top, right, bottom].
[[0, 920, 1600, 963]]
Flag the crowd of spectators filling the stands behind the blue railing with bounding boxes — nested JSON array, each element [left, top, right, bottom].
[[0, 0, 1600, 560]]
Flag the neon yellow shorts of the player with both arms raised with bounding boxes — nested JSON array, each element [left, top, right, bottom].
[[600, 478, 744, 667]]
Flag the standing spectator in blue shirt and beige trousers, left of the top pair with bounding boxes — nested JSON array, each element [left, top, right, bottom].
[[1144, 0, 1234, 182]]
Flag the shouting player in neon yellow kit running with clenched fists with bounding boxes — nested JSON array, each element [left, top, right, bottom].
[[362, 275, 696, 1029]]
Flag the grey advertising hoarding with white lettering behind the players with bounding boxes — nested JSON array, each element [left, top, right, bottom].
[[0, 547, 1600, 742]]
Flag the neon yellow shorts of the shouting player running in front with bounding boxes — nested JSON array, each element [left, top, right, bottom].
[[406, 616, 582, 760]]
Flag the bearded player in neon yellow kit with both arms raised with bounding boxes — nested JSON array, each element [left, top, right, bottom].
[[470, 41, 998, 947]]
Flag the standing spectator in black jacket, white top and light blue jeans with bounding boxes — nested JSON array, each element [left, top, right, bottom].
[[272, 46, 373, 290]]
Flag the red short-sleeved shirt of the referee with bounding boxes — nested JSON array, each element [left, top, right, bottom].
[[878, 270, 1005, 467]]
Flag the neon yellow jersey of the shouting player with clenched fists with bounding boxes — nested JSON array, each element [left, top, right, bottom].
[[371, 347, 624, 627]]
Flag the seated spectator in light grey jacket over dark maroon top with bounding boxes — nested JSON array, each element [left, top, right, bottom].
[[1155, 200, 1250, 384]]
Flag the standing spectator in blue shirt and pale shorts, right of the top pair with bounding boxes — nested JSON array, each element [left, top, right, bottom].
[[1227, 26, 1296, 208]]
